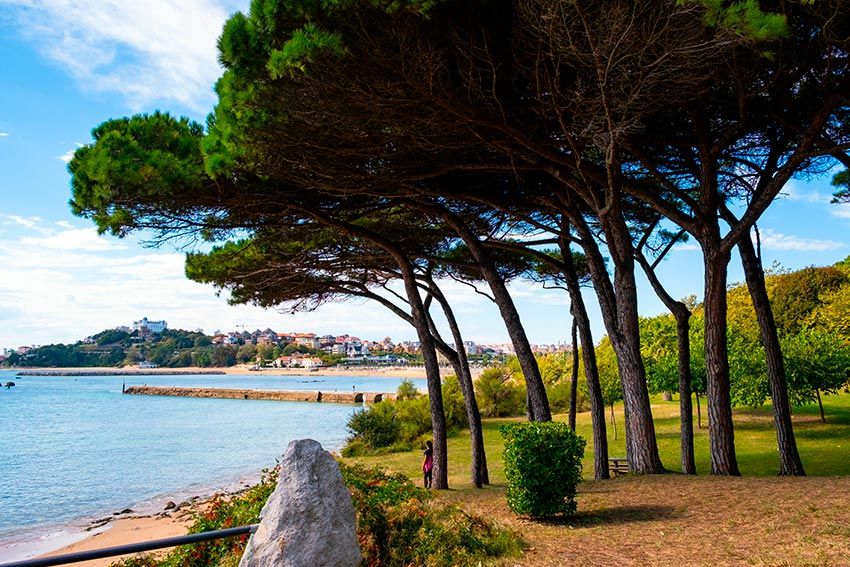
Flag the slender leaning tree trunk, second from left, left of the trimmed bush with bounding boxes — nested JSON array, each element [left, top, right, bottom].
[[431, 288, 490, 488]]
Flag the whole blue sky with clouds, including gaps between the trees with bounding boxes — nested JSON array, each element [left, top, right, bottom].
[[0, 0, 850, 347]]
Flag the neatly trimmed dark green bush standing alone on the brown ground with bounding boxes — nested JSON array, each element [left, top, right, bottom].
[[501, 421, 585, 517]]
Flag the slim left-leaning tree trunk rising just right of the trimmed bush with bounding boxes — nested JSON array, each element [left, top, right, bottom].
[[559, 227, 616, 480]]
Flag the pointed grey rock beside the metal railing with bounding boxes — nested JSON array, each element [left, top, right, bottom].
[[239, 439, 360, 567]]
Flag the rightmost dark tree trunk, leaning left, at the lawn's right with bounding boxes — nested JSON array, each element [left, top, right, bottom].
[[738, 235, 806, 476]]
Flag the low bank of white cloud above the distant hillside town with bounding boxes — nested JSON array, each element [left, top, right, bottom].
[[0, 214, 505, 347]]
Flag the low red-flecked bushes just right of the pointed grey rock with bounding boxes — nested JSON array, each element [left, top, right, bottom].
[[340, 465, 522, 567]]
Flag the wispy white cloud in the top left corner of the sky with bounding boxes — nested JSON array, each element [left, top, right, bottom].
[[0, 0, 235, 110]]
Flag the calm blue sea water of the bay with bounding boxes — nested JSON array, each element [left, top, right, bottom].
[[0, 371, 425, 562]]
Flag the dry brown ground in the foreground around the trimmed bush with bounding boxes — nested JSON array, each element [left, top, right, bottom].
[[441, 474, 850, 566]]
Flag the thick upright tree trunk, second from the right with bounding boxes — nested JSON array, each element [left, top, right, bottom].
[[703, 243, 741, 476]]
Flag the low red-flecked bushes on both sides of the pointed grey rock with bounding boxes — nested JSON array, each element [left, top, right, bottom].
[[113, 464, 522, 567]]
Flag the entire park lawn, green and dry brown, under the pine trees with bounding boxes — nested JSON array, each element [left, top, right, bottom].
[[342, 394, 850, 565]]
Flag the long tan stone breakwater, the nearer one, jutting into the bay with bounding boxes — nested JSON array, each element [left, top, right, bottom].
[[124, 386, 395, 404]]
